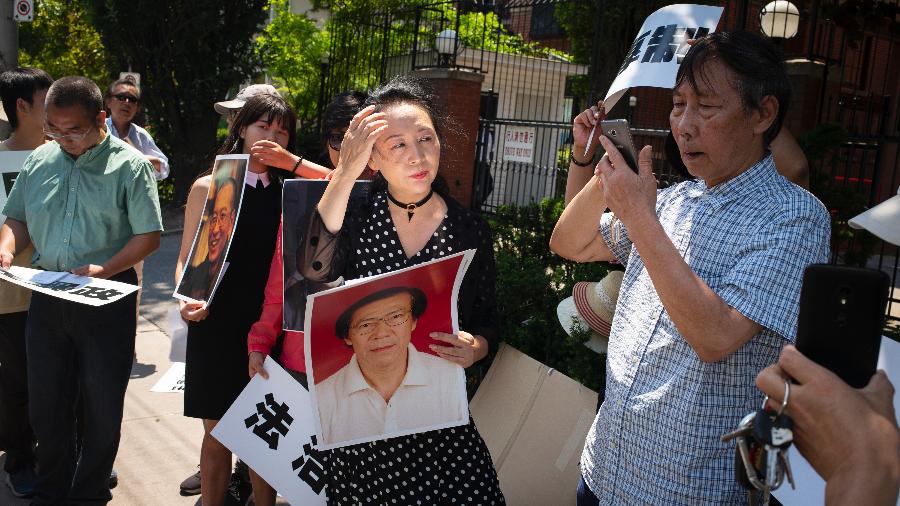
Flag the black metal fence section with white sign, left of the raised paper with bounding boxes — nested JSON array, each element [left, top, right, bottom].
[[323, 0, 588, 212]]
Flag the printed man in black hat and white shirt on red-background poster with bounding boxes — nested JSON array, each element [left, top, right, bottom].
[[314, 286, 468, 446]]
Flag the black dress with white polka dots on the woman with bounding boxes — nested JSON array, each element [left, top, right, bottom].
[[312, 192, 505, 505]]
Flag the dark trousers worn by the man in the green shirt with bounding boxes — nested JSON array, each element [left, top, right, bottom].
[[25, 269, 137, 505]]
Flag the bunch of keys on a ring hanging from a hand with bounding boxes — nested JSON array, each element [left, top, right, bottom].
[[721, 381, 794, 505]]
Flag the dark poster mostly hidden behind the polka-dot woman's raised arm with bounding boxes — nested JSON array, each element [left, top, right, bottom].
[[281, 179, 370, 332]]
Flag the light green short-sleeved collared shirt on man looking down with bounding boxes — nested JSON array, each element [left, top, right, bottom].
[[3, 134, 162, 271]]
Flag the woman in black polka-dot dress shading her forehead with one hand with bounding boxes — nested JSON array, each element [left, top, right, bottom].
[[303, 77, 505, 505]]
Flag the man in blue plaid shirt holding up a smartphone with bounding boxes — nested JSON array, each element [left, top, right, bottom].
[[550, 32, 830, 505]]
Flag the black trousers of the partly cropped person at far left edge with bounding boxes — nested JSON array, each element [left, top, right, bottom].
[[0, 311, 35, 473]]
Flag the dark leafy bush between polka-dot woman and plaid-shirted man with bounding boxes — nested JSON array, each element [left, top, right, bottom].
[[490, 199, 609, 390]]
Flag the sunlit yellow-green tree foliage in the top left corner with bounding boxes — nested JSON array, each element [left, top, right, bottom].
[[19, 0, 109, 86]]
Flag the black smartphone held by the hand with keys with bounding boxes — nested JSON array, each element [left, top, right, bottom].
[[797, 264, 890, 388]]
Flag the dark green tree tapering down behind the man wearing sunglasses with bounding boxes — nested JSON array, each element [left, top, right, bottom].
[[83, 0, 268, 203]]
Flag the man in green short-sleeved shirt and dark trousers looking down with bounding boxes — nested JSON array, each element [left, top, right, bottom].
[[0, 77, 162, 505]]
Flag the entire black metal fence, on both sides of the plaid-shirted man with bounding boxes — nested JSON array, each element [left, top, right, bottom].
[[322, 0, 900, 322]]
